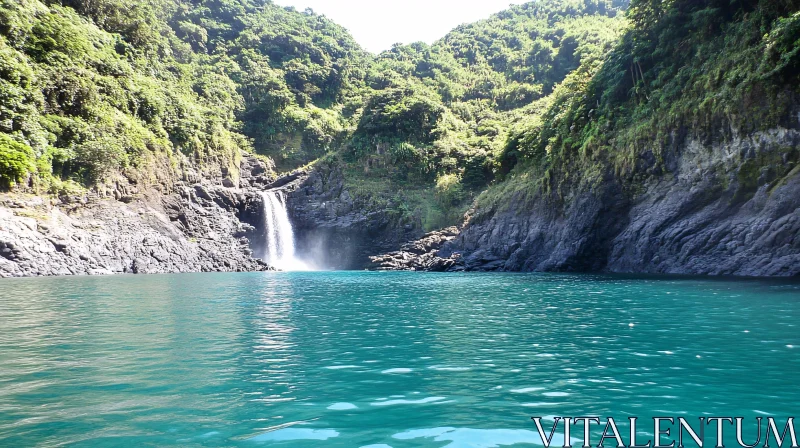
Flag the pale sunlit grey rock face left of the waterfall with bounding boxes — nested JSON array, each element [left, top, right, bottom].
[[0, 156, 274, 277]]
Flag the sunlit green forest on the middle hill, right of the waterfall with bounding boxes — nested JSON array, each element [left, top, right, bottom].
[[342, 0, 627, 228]]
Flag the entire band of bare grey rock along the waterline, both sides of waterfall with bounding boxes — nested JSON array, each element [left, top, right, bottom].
[[0, 129, 800, 277]]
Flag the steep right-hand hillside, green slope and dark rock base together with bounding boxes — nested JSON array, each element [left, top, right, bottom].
[[376, 0, 800, 276]]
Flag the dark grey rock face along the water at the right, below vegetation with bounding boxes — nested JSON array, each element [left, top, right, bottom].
[[377, 129, 800, 276]]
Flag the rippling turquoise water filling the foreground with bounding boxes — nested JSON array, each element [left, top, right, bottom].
[[0, 272, 800, 448]]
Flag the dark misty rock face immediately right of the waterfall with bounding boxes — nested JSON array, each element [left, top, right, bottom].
[[287, 166, 422, 269]]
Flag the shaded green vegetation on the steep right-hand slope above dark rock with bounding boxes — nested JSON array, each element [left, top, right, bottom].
[[484, 0, 800, 204]]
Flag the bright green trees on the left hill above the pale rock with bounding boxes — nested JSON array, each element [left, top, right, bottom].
[[0, 0, 364, 190]]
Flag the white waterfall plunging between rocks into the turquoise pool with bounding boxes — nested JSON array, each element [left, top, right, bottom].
[[261, 190, 308, 271]]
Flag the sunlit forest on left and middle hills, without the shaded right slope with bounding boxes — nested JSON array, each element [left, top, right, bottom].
[[0, 0, 625, 228]]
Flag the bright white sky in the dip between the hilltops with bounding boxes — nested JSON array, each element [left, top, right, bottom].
[[273, 0, 522, 53]]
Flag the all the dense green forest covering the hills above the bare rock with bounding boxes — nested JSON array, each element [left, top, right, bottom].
[[0, 0, 800, 229]]
